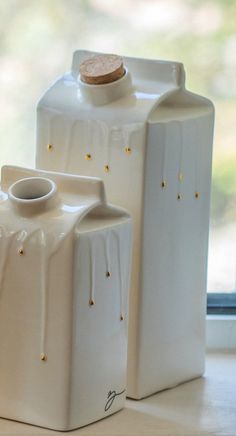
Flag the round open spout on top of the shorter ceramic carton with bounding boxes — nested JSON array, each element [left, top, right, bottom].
[[8, 177, 58, 215]]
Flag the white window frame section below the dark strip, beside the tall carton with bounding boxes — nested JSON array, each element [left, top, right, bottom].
[[206, 315, 236, 351]]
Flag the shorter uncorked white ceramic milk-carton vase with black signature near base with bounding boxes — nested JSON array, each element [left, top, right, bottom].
[[0, 167, 131, 430]]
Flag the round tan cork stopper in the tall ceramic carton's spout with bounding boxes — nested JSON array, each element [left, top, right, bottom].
[[79, 54, 125, 85]]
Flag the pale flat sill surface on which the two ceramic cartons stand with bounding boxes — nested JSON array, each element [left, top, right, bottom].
[[0, 353, 236, 436]]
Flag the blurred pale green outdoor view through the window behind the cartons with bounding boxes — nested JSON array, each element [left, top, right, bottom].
[[0, 0, 236, 292]]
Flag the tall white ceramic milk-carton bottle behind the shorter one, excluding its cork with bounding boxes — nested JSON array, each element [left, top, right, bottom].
[[36, 51, 214, 398]]
